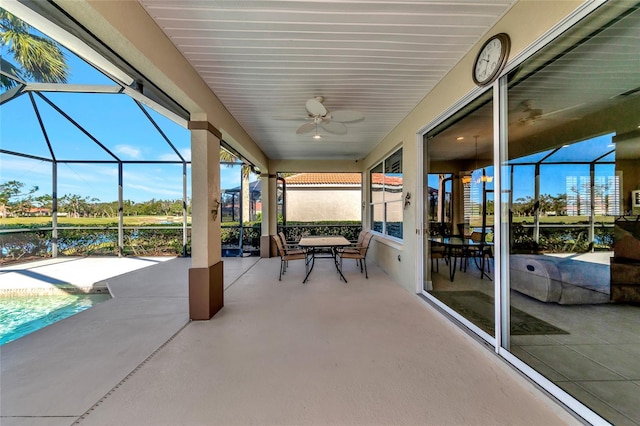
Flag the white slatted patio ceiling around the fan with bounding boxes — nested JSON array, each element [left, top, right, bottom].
[[139, 0, 515, 160]]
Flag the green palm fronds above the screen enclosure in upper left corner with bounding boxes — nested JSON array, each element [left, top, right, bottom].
[[0, 9, 69, 89]]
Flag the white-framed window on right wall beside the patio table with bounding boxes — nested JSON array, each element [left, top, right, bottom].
[[369, 148, 402, 240]]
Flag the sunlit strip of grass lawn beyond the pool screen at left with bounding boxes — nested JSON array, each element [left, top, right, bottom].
[[0, 216, 191, 228]]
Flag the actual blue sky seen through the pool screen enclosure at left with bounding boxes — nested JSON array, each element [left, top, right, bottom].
[[0, 37, 245, 202]]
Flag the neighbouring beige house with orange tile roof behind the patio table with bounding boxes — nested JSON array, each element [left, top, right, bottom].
[[284, 173, 363, 222]]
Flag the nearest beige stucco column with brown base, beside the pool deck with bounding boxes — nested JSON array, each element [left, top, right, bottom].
[[189, 117, 224, 320]]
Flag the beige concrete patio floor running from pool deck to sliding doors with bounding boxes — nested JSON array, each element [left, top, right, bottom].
[[0, 258, 580, 426]]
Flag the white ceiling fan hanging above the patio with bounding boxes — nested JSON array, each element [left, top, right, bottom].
[[274, 96, 364, 139]]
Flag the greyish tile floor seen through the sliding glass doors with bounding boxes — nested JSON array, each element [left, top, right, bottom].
[[433, 261, 640, 425]]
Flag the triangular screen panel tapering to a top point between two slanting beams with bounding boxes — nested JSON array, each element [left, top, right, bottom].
[[29, 94, 115, 161]]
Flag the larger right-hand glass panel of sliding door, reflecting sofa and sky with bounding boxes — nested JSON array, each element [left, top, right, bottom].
[[501, 2, 640, 424]]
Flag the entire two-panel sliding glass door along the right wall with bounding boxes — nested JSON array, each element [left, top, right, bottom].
[[423, 1, 640, 424]]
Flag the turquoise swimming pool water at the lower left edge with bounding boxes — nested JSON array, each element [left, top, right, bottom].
[[0, 294, 111, 345]]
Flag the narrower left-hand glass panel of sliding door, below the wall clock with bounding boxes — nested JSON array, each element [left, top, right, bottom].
[[423, 92, 495, 339]]
